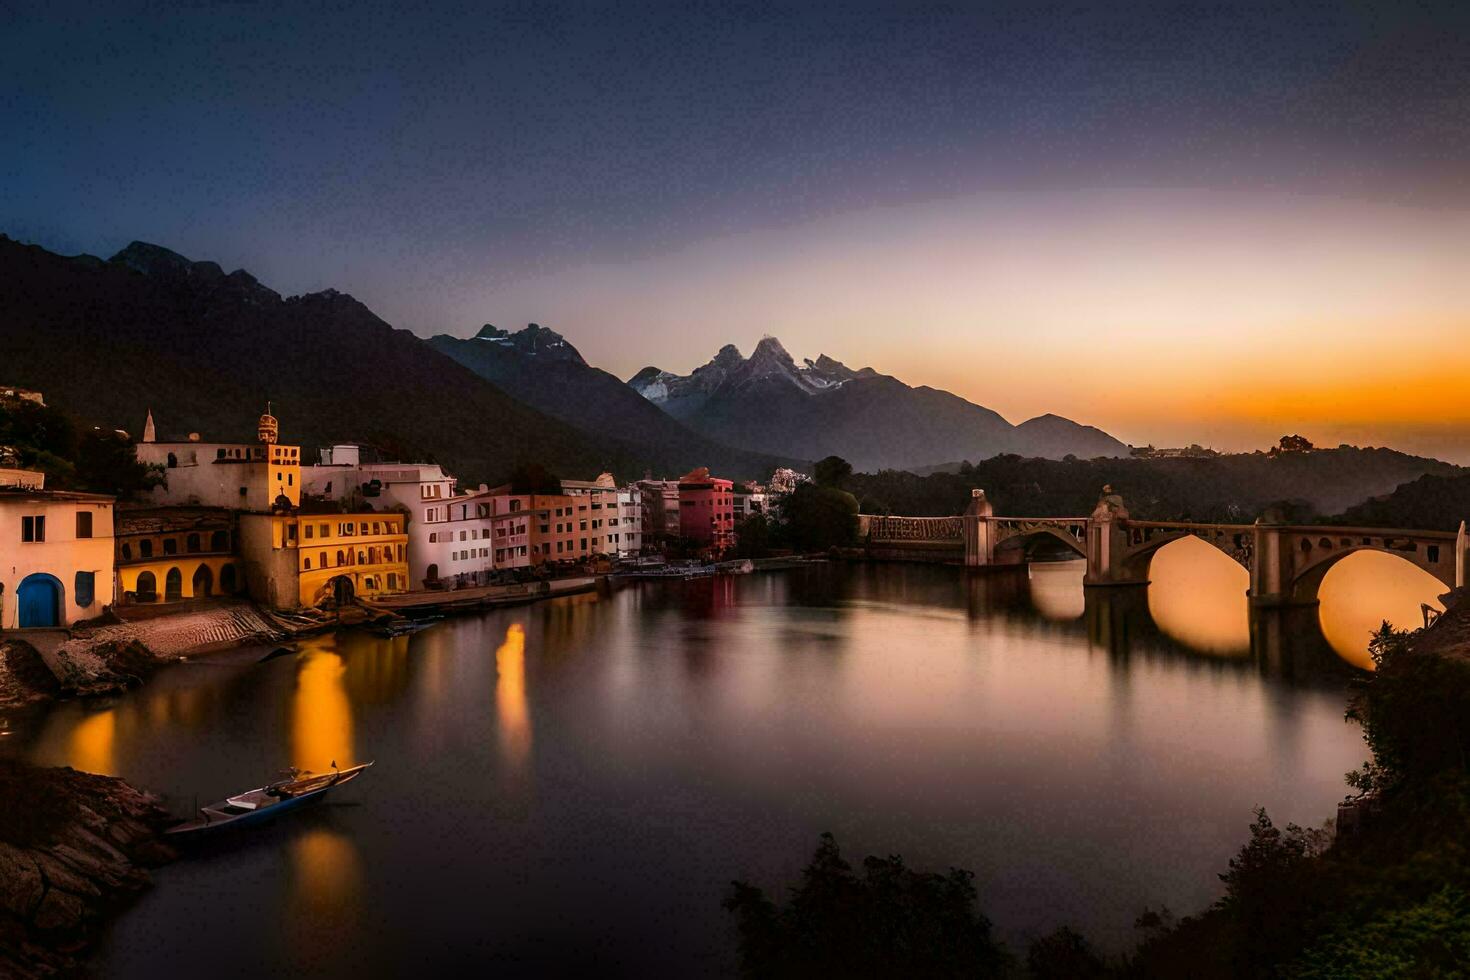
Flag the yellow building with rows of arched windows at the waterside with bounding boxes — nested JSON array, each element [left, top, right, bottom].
[[240, 513, 409, 608]]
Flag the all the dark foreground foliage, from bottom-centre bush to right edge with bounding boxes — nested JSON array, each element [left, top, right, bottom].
[[725, 624, 1470, 980]]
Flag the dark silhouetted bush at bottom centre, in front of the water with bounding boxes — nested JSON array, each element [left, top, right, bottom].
[[725, 833, 1010, 977]]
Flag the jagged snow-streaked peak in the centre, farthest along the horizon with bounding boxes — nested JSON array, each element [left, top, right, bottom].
[[628, 336, 1129, 472]]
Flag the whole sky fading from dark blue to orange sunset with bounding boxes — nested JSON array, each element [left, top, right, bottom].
[[0, 0, 1470, 463]]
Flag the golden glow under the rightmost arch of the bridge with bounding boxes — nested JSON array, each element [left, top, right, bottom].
[[1317, 551, 1448, 670]]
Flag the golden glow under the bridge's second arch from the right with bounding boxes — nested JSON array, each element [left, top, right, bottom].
[[1148, 538, 1251, 655]]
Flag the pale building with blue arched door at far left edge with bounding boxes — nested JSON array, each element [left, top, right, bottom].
[[0, 473, 113, 629]]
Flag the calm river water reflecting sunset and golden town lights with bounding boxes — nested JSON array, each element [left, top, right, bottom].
[[0, 552, 1440, 977]]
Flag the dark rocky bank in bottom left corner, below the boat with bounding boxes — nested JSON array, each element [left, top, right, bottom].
[[0, 760, 173, 980]]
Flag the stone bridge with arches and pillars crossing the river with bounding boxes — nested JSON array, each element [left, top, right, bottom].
[[858, 488, 1470, 605]]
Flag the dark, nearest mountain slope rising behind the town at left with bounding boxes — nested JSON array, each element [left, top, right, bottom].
[[0, 235, 764, 485]]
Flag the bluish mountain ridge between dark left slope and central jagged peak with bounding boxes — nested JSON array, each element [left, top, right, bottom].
[[428, 323, 791, 478]]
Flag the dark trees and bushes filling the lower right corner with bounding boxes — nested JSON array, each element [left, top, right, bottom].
[[1129, 624, 1470, 977]]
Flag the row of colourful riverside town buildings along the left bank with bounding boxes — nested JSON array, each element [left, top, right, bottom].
[[0, 399, 776, 638]]
